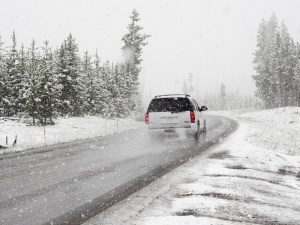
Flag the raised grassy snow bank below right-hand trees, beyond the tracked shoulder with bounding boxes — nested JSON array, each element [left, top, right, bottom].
[[236, 107, 300, 155]]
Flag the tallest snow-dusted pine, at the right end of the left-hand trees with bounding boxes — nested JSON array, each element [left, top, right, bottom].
[[122, 9, 150, 118]]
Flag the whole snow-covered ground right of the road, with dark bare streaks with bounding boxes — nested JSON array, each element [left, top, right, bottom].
[[85, 107, 300, 225]]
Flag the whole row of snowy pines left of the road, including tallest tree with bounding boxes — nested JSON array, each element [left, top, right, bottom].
[[0, 10, 149, 125]]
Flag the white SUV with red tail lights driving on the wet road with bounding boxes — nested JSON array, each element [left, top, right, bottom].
[[145, 94, 207, 133]]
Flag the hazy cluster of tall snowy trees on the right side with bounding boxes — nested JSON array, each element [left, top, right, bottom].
[[253, 14, 300, 108]]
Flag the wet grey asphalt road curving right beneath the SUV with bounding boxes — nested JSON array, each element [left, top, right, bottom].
[[0, 116, 237, 225]]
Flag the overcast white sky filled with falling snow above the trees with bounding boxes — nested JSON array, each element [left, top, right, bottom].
[[0, 0, 300, 102]]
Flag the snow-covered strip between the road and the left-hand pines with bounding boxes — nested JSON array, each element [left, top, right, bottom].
[[0, 116, 145, 154]]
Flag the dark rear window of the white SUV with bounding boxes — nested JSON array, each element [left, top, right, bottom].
[[148, 98, 192, 112]]
